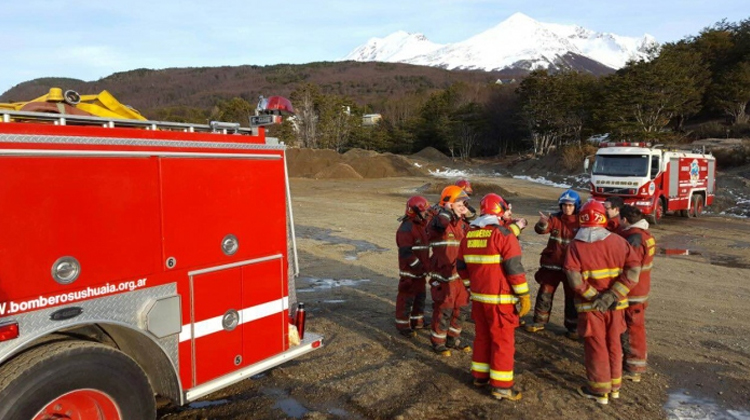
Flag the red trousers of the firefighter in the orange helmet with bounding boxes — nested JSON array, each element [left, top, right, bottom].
[[430, 280, 469, 346]]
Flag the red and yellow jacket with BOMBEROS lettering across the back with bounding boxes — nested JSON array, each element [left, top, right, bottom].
[[457, 215, 529, 312]]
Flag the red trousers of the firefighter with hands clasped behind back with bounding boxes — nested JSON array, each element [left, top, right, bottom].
[[578, 309, 626, 394]]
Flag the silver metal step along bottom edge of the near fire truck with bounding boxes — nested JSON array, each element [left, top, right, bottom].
[[183, 333, 323, 404]]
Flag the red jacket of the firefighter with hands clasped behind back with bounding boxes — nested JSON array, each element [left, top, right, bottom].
[[563, 227, 641, 313]]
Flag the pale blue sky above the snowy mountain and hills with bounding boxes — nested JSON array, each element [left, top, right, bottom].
[[0, 0, 750, 93]]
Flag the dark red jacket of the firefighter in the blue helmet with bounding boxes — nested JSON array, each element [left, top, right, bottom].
[[534, 212, 578, 270]]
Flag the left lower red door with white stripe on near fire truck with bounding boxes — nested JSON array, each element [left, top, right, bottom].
[[191, 267, 242, 385]]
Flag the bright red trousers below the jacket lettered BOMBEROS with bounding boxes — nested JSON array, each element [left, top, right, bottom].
[[471, 302, 518, 388]]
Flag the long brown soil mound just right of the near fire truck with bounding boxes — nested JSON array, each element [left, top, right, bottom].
[[287, 148, 427, 179]]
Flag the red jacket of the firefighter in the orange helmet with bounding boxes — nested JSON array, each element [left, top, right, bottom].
[[428, 209, 469, 282]]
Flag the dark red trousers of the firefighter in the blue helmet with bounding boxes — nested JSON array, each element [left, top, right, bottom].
[[534, 267, 578, 332]]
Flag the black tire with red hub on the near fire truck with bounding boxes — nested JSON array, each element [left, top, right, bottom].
[[0, 341, 156, 420]]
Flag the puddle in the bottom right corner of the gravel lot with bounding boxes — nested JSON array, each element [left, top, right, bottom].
[[664, 390, 750, 420]]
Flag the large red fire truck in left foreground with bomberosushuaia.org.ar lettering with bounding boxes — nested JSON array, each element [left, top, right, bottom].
[[0, 89, 322, 420]]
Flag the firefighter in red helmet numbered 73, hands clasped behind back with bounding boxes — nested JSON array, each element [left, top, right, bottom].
[[563, 200, 641, 404]]
